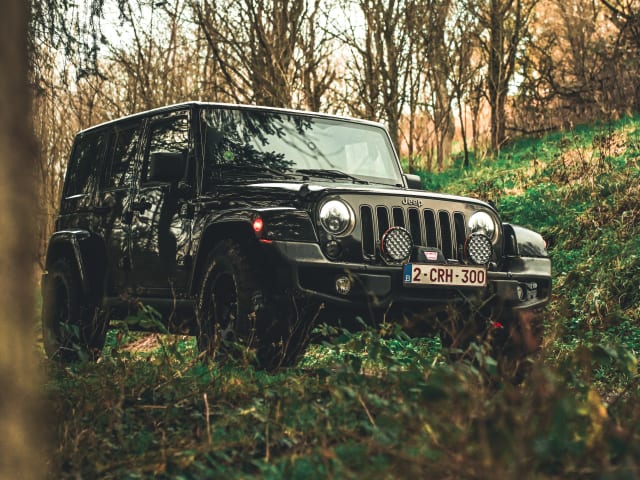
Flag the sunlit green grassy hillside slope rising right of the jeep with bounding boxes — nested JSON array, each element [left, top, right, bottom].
[[425, 118, 640, 352]]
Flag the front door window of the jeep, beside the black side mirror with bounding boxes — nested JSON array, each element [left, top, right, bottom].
[[142, 114, 189, 182]]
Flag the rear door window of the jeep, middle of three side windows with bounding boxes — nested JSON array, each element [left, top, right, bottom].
[[103, 123, 140, 189]]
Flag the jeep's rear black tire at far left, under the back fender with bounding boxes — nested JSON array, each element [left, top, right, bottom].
[[42, 258, 107, 362]]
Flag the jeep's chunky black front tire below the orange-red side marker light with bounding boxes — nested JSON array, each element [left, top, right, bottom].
[[196, 240, 313, 370]]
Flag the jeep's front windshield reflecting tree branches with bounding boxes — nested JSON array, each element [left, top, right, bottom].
[[201, 108, 402, 189]]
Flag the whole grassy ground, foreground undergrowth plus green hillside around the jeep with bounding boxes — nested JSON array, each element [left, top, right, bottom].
[[44, 118, 640, 479]]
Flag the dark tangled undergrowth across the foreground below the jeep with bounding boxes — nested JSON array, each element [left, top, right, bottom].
[[48, 329, 640, 479]]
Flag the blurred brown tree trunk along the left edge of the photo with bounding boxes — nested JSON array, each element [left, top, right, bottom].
[[0, 0, 45, 479]]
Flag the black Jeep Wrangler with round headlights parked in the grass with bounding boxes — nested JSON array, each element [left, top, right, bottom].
[[42, 102, 551, 368]]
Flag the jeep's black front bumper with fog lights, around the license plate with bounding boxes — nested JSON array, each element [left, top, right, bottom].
[[267, 241, 551, 310]]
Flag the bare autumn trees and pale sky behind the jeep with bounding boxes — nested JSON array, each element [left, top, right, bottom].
[[30, 0, 640, 268]]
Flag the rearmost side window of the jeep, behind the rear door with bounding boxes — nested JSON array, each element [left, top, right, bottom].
[[64, 132, 105, 198]]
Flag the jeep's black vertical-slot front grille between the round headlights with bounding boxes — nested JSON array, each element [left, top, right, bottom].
[[360, 205, 466, 260]]
